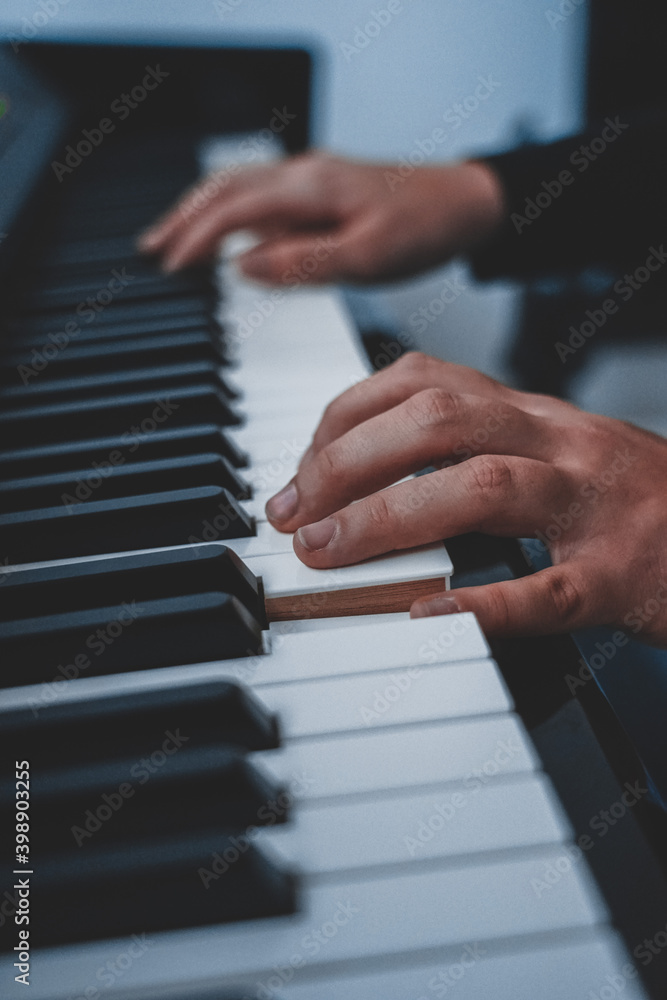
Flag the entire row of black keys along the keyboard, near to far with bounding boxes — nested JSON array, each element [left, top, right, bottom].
[[0, 139, 294, 946]]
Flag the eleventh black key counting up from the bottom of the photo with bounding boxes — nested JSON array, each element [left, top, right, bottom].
[[0, 330, 224, 389]]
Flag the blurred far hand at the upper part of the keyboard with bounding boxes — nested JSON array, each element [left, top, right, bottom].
[[137, 152, 504, 284]]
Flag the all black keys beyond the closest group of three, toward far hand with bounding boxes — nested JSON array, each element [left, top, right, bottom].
[[0, 145, 274, 668]]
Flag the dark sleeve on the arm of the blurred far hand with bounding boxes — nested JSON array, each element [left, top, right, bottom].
[[471, 112, 667, 279]]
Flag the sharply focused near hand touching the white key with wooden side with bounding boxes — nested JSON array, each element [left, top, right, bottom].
[[267, 353, 667, 646]]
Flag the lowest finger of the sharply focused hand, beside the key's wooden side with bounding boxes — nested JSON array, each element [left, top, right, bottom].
[[410, 560, 615, 637]]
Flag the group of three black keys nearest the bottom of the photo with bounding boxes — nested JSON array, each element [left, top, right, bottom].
[[0, 681, 294, 947]]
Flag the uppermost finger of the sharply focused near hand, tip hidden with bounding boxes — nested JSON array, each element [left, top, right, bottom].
[[312, 351, 520, 451]]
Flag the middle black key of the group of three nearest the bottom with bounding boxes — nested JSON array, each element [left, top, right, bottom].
[[0, 752, 290, 859]]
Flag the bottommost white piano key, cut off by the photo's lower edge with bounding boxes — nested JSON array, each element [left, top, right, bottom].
[[276, 928, 649, 1000]]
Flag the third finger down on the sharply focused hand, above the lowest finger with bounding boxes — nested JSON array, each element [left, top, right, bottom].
[[294, 455, 571, 569]]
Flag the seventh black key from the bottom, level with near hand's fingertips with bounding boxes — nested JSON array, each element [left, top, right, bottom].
[[0, 454, 252, 513]]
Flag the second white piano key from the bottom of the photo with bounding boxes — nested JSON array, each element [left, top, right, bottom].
[[18, 848, 606, 1000]]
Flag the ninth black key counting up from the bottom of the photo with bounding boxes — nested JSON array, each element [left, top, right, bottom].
[[0, 383, 239, 446]]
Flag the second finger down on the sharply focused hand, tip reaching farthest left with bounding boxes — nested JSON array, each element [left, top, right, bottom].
[[266, 389, 554, 531]]
